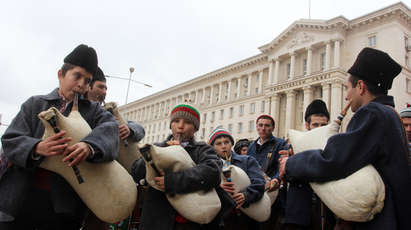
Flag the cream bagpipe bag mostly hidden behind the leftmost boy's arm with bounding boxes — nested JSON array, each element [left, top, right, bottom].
[[104, 102, 141, 172]]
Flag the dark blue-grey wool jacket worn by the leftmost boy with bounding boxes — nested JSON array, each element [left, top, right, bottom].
[[0, 89, 119, 219]]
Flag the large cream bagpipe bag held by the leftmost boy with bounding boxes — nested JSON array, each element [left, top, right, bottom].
[[38, 107, 137, 223]]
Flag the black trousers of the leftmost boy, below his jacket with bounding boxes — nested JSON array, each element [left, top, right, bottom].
[[0, 189, 82, 230]]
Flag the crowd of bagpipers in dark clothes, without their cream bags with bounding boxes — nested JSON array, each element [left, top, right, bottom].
[[0, 45, 411, 230]]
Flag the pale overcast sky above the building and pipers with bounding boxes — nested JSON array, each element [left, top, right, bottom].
[[0, 0, 411, 138]]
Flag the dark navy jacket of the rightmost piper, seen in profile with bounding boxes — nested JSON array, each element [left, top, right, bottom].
[[286, 96, 411, 230]]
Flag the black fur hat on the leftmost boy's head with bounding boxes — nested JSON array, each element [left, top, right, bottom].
[[64, 44, 98, 75]]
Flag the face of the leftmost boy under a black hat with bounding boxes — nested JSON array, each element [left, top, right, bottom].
[[58, 66, 93, 101]]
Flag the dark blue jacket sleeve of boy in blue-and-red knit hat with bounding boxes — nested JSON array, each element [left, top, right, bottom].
[[227, 151, 265, 208]]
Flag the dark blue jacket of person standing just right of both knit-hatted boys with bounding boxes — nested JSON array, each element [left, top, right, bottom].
[[247, 136, 289, 179]]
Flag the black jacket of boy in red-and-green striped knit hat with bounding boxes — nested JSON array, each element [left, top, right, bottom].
[[131, 136, 221, 230]]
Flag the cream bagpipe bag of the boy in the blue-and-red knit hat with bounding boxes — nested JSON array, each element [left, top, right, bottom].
[[221, 165, 271, 222]]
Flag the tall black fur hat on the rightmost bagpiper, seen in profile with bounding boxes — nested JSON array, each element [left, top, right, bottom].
[[348, 47, 402, 90]]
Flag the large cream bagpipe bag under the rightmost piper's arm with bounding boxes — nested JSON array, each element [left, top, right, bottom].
[[288, 122, 385, 222]]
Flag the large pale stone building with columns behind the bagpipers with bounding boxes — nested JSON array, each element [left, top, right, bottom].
[[120, 2, 411, 143]]
